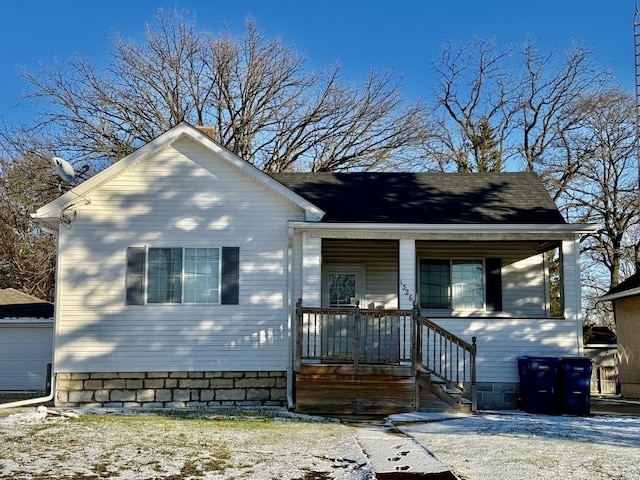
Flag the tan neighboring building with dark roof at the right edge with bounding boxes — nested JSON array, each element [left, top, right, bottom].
[[600, 273, 640, 398]]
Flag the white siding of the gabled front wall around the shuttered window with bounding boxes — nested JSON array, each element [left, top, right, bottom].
[[56, 138, 304, 372]]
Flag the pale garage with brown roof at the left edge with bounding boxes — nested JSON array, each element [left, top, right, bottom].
[[0, 288, 53, 391]]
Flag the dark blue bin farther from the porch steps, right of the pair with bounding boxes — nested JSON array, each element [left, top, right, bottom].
[[560, 357, 593, 416]]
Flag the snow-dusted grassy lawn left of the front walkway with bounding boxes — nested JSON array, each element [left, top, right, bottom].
[[0, 409, 374, 480]]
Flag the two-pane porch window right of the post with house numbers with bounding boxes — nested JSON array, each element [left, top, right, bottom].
[[420, 259, 485, 310]]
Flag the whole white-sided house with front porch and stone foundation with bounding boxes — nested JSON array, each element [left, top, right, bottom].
[[34, 124, 593, 409]]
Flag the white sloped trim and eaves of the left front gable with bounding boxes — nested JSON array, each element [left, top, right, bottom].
[[32, 122, 324, 230]]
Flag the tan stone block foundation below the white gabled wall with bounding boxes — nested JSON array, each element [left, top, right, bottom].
[[55, 371, 287, 408]]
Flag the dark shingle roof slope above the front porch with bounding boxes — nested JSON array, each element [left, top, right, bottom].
[[271, 172, 565, 224]]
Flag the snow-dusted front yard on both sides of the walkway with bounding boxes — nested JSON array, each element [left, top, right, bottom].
[[0, 409, 640, 480]]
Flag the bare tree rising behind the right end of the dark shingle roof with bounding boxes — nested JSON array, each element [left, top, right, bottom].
[[426, 38, 610, 173]]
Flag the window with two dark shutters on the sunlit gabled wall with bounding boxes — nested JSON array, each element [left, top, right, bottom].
[[126, 247, 239, 305]]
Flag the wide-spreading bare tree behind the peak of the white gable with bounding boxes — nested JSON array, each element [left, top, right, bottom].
[[16, 12, 425, 171]]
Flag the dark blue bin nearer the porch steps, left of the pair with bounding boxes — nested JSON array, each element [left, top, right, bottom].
[[518, 356, 560, 415]]
